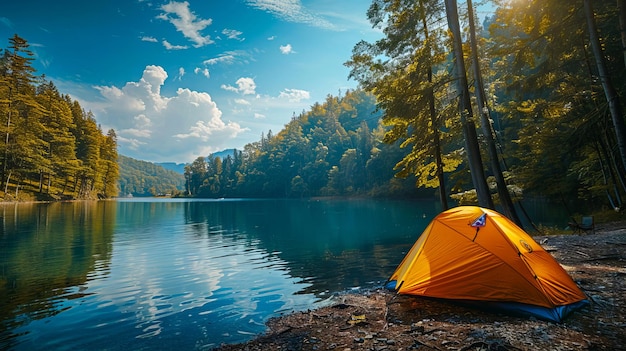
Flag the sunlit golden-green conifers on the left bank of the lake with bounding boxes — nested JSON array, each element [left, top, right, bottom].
[[0, 34, 119, 200]]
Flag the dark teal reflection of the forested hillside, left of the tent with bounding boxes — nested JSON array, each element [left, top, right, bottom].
[[185, 200, 435, 295]]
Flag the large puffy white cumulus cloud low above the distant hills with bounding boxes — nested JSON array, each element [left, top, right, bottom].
[[89, 66, 246, 162]]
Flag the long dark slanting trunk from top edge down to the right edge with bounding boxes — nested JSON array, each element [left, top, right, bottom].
[[583, 0, 626, 173]]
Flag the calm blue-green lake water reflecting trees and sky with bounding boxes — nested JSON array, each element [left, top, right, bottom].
[[0, 199, 567, 350]]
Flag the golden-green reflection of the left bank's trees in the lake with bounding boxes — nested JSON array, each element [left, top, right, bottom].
[[0, 201, 116, 346]]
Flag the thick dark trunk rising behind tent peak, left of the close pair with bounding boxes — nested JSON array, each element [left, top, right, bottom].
[[445, 0, 493, 208]]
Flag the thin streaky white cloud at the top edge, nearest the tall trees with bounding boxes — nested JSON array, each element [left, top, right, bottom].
[[246, 0, 337, 30]]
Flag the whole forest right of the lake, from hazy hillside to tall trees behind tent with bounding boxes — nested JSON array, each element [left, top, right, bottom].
[[185, 0, 626, 224]]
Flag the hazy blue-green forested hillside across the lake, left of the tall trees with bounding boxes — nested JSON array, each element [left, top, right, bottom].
[[185, 90, 424, 198]]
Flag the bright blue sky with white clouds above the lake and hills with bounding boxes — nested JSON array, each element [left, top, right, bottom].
[[0, 0, 382, 163]]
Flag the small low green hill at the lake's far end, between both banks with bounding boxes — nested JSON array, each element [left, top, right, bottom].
[[118, 155, 185, 196]]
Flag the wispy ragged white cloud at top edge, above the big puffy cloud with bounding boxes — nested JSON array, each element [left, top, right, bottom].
[[157, 1, 214, 47]]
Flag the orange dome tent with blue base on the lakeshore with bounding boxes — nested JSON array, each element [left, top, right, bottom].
[[389, 206, 586, 322]]
